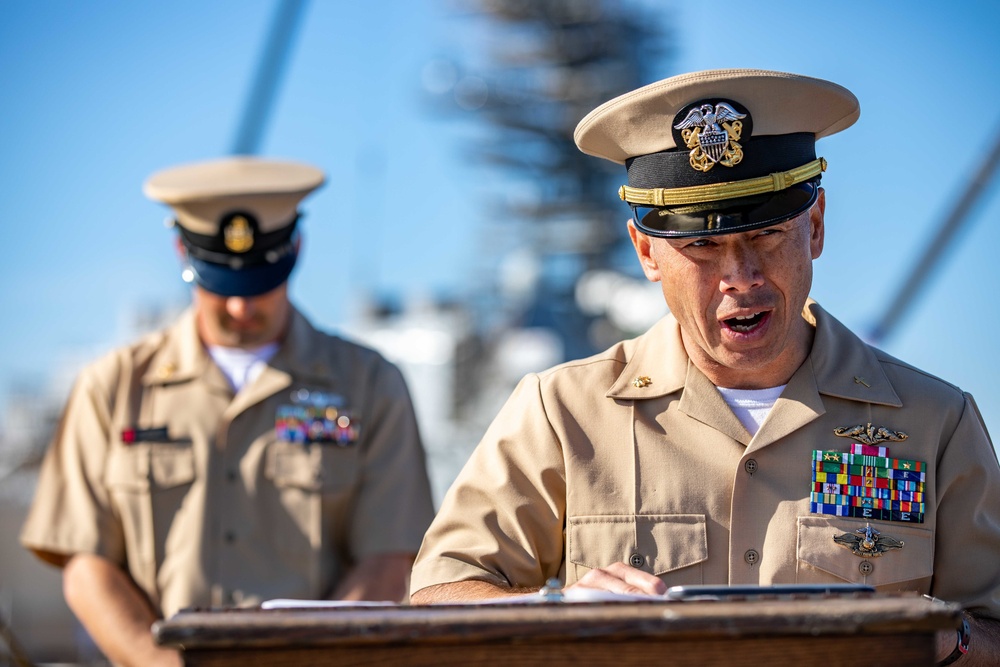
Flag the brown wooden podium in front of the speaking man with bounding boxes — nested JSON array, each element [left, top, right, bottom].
[[153, 594, 961, 667]]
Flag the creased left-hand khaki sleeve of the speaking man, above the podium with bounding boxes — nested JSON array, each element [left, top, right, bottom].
[[410, 375, 566, 593]]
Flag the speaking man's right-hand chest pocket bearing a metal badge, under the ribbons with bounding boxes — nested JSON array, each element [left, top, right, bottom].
[[797, 516, 934, 586]]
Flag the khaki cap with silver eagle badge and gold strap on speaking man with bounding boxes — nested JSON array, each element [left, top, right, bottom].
[[574, 69, 861, 237]]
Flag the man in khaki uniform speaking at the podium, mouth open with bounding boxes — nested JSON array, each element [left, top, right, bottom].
[[411, 70, 1000, 664]]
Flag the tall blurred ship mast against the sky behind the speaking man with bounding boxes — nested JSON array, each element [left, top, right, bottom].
[[424, 0, 668, 358]]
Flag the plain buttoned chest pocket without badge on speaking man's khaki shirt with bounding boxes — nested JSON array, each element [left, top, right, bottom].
[[566, 514, 708, 586]]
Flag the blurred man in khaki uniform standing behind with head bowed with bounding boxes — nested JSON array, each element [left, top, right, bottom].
[[21, 158, 433, 665]]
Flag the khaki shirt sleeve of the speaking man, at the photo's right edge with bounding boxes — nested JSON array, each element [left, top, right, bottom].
[[932, 394, 1000, 619]]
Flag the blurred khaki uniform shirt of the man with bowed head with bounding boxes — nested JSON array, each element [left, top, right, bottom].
[[21, 310, 433, 617]]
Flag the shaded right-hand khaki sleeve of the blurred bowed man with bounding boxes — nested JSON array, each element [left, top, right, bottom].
[[349, 361, 434, 560]]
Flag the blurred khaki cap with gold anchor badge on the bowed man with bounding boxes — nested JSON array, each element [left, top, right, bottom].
[[143, 156, 325, 296]]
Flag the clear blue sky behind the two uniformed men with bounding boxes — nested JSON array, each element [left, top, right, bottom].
[[0, 0, 1000, 446]]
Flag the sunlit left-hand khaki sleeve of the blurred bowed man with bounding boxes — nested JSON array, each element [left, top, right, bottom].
[[21, 360, 125, 565]]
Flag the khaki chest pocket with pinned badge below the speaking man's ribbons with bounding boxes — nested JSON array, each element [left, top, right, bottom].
[[796, 515, 934, 593]]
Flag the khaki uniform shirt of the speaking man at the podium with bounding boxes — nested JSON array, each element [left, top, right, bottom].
[[410, 303, 1000, 618]]
